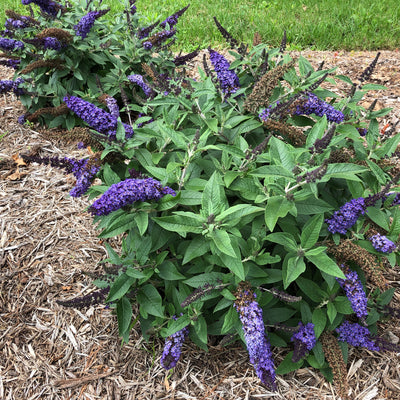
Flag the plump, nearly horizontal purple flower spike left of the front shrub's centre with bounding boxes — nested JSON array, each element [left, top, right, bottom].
[[89, 178, 176, 215]]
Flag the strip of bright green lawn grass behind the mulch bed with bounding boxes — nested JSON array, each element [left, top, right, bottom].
[[0, 0, 400, 51]]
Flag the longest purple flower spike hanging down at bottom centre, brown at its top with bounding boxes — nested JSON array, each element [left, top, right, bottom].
[[235, 290, 276, 390]]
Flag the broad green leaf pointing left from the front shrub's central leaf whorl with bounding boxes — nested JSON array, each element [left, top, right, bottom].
[[152, 211, 206, 237]]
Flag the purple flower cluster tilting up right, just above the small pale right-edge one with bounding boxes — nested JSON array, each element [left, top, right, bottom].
[[325, 197, 366, 235]]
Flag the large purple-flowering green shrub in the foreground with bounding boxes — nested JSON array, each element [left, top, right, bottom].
[[10, 4, 400, 397]]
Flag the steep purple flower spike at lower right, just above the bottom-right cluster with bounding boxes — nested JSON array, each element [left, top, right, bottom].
[[336, 264, 368, 318]]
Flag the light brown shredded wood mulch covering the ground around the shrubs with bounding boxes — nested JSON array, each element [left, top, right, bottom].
[[0, 51, 400, 400]]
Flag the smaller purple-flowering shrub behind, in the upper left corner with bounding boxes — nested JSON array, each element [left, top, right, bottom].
[[0, 0, 187, 129]]
